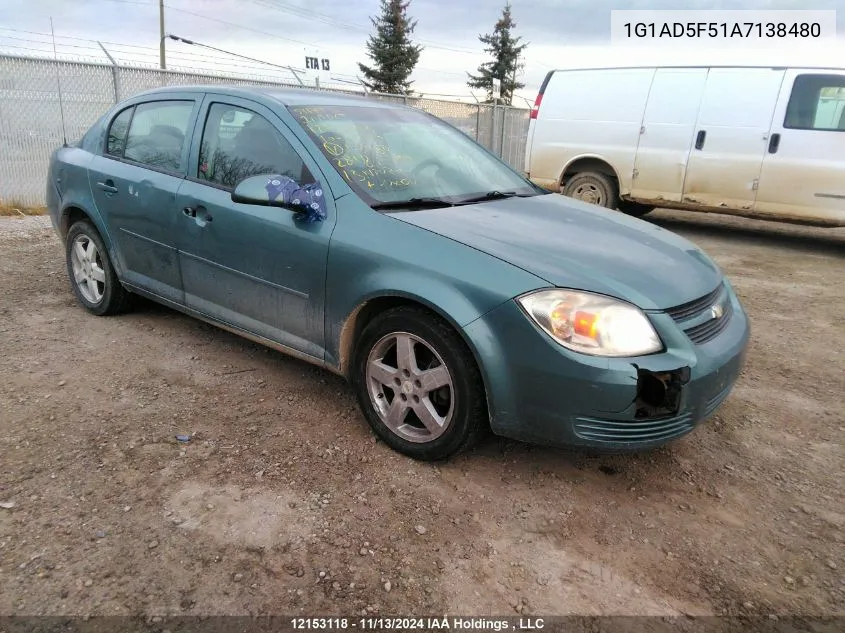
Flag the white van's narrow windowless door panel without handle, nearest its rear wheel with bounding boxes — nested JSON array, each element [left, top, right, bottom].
[[631, 68, 707, 202]]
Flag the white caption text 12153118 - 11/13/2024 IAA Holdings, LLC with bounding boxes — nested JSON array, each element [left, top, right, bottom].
[[290, 616, 545, 631]]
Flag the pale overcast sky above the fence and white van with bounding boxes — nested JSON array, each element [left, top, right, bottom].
[[0, 0, 845, 100]]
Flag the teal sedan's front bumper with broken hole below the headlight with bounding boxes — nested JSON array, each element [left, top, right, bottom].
[[464, 285, 750, 451]]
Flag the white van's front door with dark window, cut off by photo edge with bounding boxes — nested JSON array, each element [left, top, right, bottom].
[[754, 70, 845, 223]]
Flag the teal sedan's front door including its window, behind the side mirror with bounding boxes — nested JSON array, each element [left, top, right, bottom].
[[177, 95, 335, 359]]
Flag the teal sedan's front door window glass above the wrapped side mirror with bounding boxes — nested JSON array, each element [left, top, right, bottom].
[[196, 103, 314, 189]]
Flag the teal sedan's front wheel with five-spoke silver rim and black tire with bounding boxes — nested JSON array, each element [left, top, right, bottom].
[[352, 306, 487, 461]]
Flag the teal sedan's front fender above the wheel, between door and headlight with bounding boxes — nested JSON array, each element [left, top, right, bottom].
[[325, 199, 548, 371]]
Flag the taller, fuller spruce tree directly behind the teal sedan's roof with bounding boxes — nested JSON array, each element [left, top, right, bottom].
[[358, 0, 422, 95]]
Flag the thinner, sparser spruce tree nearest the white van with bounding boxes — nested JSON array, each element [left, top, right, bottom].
[[467, 3, 528, 105]]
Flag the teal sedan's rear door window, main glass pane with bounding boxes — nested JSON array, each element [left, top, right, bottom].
[[123, 101, 194, 172]]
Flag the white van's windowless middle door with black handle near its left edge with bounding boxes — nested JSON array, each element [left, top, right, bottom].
[[683, 68, 784, 210]]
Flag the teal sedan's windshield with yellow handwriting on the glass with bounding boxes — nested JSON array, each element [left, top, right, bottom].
[[289, 106, 544, 209]]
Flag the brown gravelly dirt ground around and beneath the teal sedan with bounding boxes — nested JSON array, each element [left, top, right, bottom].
[[0, 212, 845, 616]]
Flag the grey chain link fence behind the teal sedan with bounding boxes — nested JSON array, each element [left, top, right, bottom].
[[0, 55, 529, 206]]
